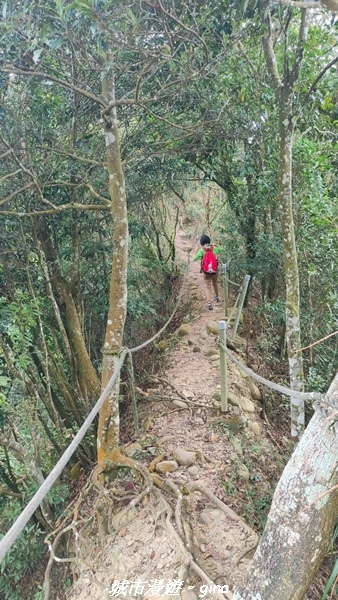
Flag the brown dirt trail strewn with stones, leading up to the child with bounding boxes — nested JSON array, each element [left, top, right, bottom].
[[68, 232, 262, 600]]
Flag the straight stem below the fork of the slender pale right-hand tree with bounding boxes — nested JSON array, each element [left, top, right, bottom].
[[279, 92, 305, 442]]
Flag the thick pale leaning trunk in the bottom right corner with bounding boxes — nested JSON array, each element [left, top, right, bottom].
[[233, 375, 338, 600]]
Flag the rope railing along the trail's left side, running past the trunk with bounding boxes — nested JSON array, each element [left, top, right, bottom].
[[0, 260, 189, 561]]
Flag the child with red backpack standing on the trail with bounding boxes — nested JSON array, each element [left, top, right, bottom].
[[193, 235, 223, 310]]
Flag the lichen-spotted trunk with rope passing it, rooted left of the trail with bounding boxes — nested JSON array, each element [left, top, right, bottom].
[[97, 59, 128, 470]]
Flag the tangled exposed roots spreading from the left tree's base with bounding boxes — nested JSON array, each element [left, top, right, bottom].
[[44, 450, 258, 600]]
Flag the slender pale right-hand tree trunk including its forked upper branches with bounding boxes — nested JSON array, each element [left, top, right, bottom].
[[262, 0, 308, 442]]
